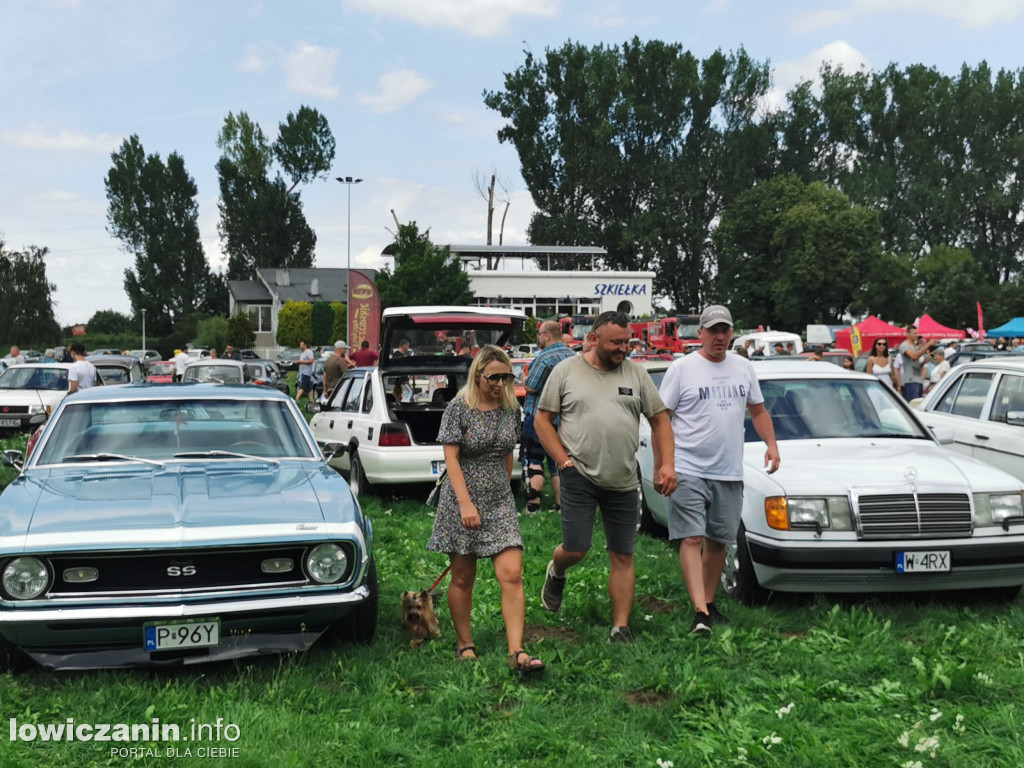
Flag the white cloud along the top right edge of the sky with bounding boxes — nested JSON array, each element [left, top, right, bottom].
[[790, 0, 1024, 33]]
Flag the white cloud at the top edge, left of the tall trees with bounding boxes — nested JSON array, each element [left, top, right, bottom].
[[345, 0, 559, 37]]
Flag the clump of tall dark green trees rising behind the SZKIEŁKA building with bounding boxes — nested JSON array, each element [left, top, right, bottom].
[[484, 38, 775, 306]]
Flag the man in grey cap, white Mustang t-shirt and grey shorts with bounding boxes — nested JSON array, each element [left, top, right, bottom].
[[659, 304, 779, 633]]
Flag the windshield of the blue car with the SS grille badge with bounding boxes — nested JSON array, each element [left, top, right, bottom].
[[37, 399, 313, 465]]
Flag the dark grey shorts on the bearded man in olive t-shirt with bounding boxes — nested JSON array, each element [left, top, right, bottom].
[[558, 467, 640, 555]]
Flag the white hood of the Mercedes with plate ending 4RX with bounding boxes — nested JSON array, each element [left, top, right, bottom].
[[743, 438, 1024, 496]]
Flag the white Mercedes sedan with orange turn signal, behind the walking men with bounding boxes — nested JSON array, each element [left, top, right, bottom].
[[638, 361, 1024, 604]]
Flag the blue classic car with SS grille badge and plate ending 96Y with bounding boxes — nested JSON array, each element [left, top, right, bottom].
[[0, 384, 378, 669]]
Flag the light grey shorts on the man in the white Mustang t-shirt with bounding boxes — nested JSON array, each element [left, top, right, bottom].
[[669, 475, 743, 544]]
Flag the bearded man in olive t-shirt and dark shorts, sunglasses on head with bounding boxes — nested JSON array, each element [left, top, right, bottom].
[[535, 312, 676, 642]]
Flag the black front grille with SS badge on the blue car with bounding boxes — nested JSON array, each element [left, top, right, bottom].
[[41, 542, 356, 599]]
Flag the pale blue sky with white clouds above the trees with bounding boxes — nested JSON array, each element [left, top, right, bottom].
[[0, 0, 1024, 325]]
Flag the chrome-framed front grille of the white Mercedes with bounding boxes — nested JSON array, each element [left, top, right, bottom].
[[853, 494, 974, 539]]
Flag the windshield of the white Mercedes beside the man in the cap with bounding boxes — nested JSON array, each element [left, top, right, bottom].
[[744, 379, 930, 442]]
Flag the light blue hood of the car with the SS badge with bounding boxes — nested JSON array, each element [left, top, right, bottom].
[[0, 462, 358, 551]]
